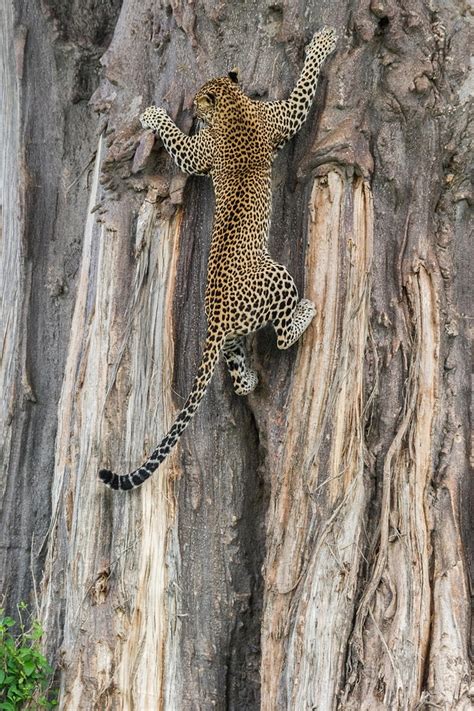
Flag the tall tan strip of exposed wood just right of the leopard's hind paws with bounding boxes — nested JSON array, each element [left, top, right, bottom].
[[262, 171, 373, 709]]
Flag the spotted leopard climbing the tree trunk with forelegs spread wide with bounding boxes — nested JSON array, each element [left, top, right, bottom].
[[99, 23, 336, 489]]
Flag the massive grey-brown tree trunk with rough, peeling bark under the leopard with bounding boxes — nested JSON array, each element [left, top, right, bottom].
[[0, 0, 472, 711]]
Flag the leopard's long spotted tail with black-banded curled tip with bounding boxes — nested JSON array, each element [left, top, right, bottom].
[[99, 335, 224, 490]]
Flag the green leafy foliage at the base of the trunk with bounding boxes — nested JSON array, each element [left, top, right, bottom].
[[0, 603, 57, 711]]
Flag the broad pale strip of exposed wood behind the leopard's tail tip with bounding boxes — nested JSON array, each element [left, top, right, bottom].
[[43, 138, 181, 710]]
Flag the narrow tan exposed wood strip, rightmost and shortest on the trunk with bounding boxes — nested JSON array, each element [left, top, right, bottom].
[[349, 264, 440, 707]]
